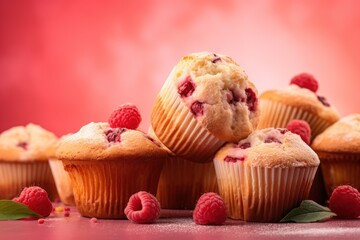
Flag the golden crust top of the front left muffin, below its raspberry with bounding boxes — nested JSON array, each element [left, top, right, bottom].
[[56, 122, 168, 161]]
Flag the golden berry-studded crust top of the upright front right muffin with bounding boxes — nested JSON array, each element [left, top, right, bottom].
[[214, 128, 320, 168]]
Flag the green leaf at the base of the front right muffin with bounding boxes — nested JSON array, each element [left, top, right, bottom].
[[280, 200, 336, 223]]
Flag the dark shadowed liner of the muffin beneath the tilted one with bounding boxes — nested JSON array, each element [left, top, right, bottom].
[[156, 157, 218, 209]]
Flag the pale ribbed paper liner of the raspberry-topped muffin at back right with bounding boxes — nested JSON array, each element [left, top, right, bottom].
[[258, 100, 332, 139]]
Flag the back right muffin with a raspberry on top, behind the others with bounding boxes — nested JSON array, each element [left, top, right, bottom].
[[258, 73, 340, 138]]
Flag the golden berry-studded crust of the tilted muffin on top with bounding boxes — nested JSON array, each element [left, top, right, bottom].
[[151, 52, 259, 142]]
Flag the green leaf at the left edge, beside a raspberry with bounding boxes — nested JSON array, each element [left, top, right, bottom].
[[0, 200, 41, 220]]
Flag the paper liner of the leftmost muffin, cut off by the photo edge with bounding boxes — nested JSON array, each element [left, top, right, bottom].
[[0, 161, 58, 200]]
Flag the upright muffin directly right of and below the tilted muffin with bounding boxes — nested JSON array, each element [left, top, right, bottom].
[[214, 128, 320, 222]]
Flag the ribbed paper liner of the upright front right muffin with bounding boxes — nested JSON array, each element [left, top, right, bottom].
[[214, 160, 317, 222]]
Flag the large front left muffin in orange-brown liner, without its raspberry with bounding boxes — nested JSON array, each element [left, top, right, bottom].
[[56, 122, 168, 218]]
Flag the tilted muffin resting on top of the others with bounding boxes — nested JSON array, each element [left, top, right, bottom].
[[151, 52, 259, 162]]
